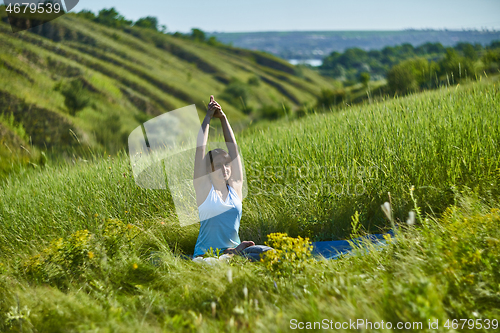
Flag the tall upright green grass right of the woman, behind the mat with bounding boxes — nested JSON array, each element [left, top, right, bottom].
[[241, 78, 500, 238]]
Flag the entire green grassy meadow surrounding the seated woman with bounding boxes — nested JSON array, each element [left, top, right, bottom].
[[0, 77, 500, 332]]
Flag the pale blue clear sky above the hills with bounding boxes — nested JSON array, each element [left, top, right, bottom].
[[73, 0, 500, 32]]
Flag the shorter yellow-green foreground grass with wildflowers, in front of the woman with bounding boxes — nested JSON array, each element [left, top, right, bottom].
[[0, 187, 500, 332]]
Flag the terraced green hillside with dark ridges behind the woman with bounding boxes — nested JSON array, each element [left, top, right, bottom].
[[0, 6, 334, 175]]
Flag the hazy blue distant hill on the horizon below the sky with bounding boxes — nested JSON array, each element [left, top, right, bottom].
[[209, 30, 500, 59]]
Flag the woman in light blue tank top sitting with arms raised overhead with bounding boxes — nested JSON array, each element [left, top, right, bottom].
[[193, 96, 271, 260]]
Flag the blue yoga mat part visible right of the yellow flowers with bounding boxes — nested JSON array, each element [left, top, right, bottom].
[[312, 230, 394, 259]]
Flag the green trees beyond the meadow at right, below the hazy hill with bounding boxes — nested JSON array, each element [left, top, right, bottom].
[[320, 41, 500, 94]]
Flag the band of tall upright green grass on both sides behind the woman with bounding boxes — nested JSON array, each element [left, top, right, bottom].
[[0, 83, 500, 253]]
